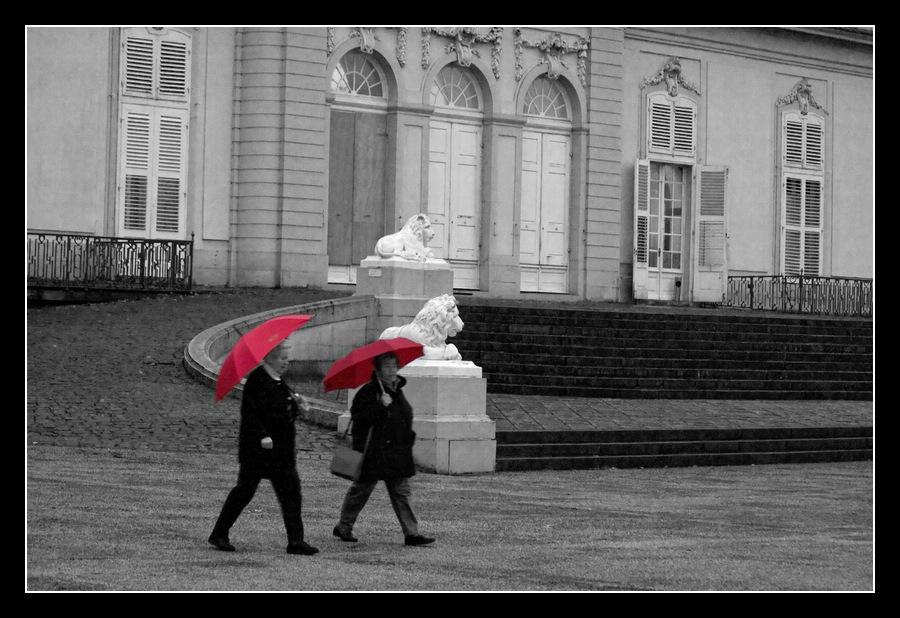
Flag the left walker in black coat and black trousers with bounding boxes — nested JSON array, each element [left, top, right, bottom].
[[209, 343, 319, 556]]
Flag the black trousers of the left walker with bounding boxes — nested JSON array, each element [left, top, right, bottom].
[[213, 467, 303, 543]]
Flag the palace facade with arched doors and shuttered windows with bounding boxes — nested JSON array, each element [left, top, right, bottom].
[[26, 27, 875, 302]]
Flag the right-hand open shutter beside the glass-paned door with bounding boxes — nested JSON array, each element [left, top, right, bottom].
[[692, 166, 728, 302]]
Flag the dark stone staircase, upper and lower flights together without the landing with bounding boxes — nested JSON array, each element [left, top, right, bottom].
[[452, 298, 874, 471]]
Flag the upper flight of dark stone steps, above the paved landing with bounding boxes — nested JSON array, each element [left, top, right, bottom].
[[452, 299, 874, 400]]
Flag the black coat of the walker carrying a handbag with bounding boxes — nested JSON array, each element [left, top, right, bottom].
[[350, 374, 416, 481]]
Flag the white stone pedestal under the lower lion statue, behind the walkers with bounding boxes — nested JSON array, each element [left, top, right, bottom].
[[338, 359, 497, 474]]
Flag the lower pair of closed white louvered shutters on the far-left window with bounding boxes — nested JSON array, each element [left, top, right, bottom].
[[118, 105, 187, 239]]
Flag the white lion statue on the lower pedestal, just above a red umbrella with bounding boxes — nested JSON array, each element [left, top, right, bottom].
[[379, 294, 463, 360]]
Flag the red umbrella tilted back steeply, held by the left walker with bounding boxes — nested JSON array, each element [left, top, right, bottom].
[[216, 315, 313, 401]]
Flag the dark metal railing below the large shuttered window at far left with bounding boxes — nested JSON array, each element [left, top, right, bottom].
[[28, 233, 194, 291]]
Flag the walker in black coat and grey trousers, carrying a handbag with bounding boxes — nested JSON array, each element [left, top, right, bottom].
[[334, 353, 434, 545]]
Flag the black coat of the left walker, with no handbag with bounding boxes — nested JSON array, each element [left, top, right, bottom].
[[238, 365, 299, 478]]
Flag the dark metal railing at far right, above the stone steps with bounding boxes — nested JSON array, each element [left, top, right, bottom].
[[723, 273, 874, 317]]
